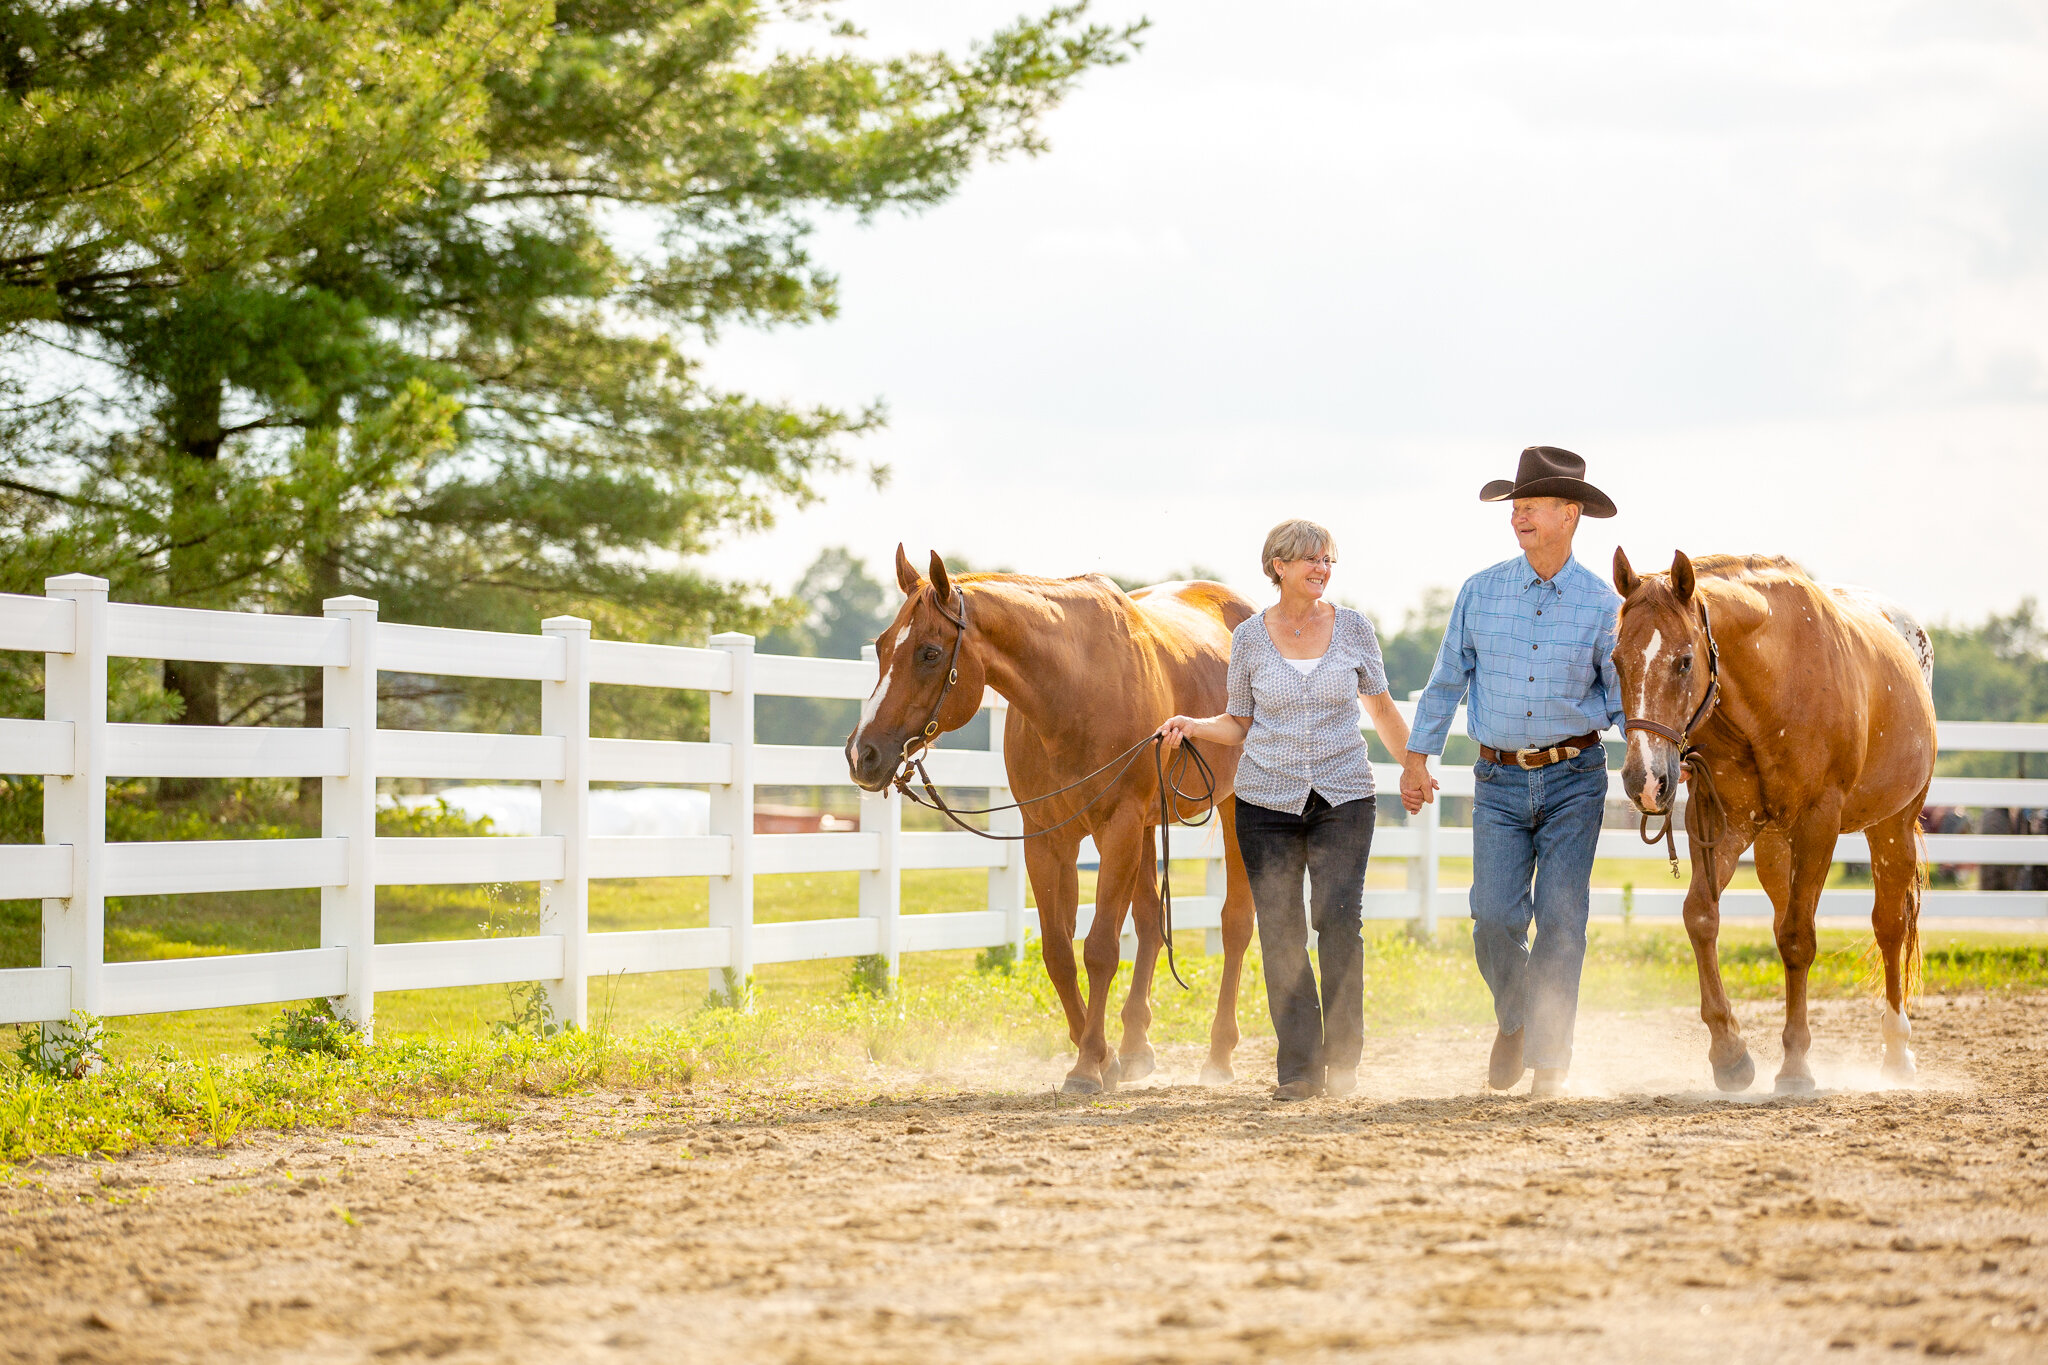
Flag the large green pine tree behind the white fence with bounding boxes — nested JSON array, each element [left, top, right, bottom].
[[0, 0, 1137, 749]]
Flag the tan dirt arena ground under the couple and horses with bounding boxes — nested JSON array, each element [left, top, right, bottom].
[[0, 997, 2048, 1365]]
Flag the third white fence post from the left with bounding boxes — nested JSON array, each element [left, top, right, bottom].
[[541, 616, 590, 1027]]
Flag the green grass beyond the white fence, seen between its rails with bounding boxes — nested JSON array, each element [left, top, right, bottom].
[[0, 862, 2048, 1058]]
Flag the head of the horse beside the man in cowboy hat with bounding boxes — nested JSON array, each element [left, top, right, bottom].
[[1614, 546, 1716, 814]]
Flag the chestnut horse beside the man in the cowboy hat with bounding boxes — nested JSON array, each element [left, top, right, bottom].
[[1614, 551, 1935, 1091]]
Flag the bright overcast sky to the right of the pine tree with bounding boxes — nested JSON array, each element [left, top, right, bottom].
[[692, 0, 2048, 624]]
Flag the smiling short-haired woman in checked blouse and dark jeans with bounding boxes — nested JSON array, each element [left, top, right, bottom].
[[1159, 520, 1407, 1099]]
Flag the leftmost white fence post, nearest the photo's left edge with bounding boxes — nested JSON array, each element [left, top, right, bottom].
[[43, 573, 106, 1042]]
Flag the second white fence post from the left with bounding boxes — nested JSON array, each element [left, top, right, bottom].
[[319, 598, 377, 1033]]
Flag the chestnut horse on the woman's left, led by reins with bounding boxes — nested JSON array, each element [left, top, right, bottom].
[[846, 544, 1253, 1095]]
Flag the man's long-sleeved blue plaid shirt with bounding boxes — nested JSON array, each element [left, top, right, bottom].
[[1409, 555, 1624, 753]]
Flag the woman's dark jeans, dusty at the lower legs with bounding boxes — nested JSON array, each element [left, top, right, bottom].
[[1237, 792, 1376, 1085]]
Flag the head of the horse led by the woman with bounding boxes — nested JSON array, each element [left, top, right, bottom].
[[846, 544, 987, 792]]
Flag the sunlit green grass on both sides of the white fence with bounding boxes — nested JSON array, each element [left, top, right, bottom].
[[0, 847, 2048, 1160]]
